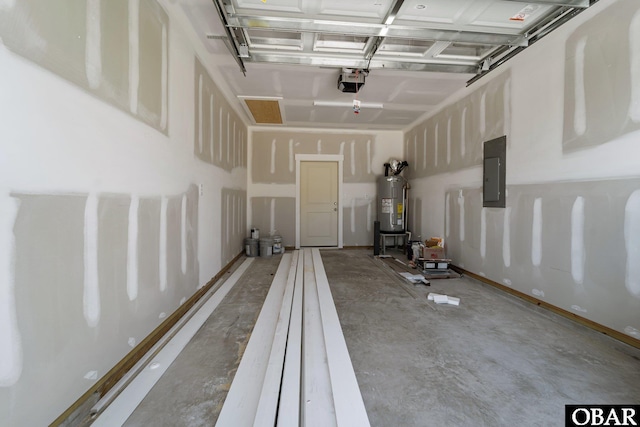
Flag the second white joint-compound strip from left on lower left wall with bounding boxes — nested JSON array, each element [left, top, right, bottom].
[[82, 193, 100, 328]]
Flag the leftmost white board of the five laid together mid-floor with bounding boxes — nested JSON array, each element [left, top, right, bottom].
[[216, 254, 292, 427]]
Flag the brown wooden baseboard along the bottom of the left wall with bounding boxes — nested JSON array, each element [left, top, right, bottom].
[[50, 251, 244, 426]]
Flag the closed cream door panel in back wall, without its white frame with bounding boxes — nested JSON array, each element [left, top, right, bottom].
[[300, 161, 339, 246]]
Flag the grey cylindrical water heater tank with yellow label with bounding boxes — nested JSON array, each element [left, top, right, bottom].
[[378, 175, 407, 233]]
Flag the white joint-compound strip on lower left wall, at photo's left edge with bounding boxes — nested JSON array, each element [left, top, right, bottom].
[[0, 194, 23, 387]]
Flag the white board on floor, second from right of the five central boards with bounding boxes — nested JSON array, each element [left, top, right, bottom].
[[301, 249, 337, 427]]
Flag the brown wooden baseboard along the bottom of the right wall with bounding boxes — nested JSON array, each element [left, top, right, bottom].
[[451, 265, 640, 348]]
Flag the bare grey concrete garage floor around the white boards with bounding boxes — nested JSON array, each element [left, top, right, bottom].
[[125, 250, 640, 427]]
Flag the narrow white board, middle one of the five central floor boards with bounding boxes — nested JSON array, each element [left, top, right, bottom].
[[276, 251, 304, 427]]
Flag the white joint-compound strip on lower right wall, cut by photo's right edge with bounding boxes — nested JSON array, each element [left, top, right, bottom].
[[624, 190, 640, 297]]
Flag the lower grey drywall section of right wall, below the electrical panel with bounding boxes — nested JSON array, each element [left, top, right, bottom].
[[445, 179, 640, 338]]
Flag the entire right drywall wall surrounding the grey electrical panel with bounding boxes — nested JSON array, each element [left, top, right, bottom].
[[405, 0, 640, 338]]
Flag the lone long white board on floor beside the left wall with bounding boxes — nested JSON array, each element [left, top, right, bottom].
[[92, 258, 253, 427]]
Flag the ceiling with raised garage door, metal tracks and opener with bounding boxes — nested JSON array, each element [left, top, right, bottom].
[[180, 0, 597, 130]]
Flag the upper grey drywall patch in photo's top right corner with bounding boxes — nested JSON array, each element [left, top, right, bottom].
[[563, 1, 640, 152]]
